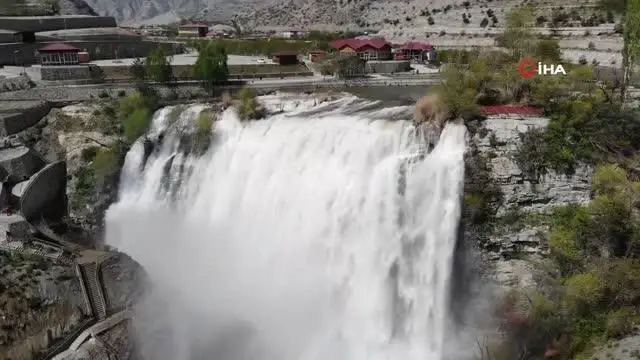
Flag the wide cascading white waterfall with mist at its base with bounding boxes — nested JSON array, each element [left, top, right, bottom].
[[107, 96, 465, 360]]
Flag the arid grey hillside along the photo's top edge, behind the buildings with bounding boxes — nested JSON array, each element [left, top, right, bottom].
[[75, 0, 616, 30]]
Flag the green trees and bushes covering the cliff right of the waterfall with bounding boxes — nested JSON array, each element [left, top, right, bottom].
[[433, 6, 640, 360]]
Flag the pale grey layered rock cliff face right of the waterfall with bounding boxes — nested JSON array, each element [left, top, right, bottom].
[[467, 116, 592, 286]]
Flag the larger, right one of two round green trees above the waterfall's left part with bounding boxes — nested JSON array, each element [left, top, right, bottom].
[[194, 42, 229, 94]]
